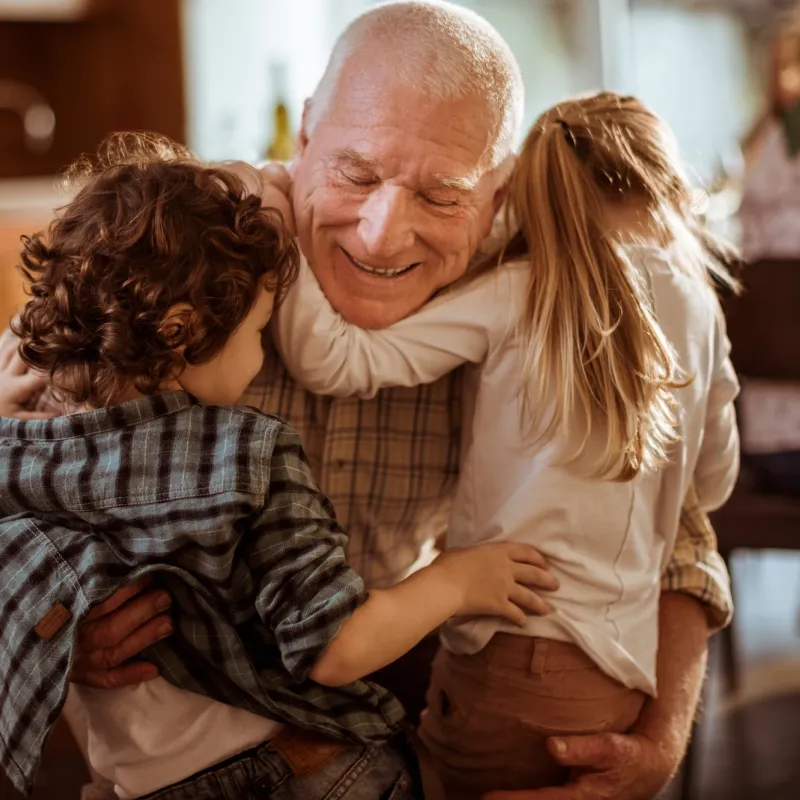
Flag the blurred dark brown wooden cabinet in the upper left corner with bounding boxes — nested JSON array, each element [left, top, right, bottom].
[[0, 0, 185, 178]]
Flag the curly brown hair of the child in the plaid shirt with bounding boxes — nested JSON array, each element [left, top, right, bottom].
[[14, 133, 298, 407]]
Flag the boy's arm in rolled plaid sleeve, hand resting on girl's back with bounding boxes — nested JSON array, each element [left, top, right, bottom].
[[245, 426, 555, 685]]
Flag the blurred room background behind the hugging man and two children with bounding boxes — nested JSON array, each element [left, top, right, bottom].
[[0, 0, 800, 800]]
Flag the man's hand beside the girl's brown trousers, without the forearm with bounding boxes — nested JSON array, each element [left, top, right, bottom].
[[482, 733, 680, 800]]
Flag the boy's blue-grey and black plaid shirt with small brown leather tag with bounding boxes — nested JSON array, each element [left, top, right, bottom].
[[0, 392, 403, 791]]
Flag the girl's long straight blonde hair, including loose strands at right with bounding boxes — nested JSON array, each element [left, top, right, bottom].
[[504, 92, 733, 481]]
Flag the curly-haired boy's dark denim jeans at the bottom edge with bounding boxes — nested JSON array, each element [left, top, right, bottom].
[[142, 744, 422, 800]]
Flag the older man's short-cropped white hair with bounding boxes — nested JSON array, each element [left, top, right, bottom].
[[306, 0, 524, 167]]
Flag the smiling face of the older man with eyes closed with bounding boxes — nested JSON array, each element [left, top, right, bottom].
[[293, 57, 499, 328]]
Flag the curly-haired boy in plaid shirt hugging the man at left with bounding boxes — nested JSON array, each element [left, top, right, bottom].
[[0, 134, 542, 800]]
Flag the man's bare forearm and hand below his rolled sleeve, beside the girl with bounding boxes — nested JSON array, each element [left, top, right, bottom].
[[482, 592, 708, 800]]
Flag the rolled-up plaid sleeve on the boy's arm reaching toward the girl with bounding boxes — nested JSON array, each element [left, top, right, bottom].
[[248, 425, 367, 682]]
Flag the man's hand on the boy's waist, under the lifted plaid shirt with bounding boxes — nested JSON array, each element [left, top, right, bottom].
[[70, 578, 172, 689]]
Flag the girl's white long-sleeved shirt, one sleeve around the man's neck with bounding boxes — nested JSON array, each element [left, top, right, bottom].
[[273, 242, 739, 694]]
